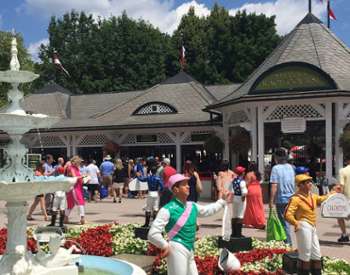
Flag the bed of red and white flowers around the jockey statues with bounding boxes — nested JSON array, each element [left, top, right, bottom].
[[0, 224, 350, 275]]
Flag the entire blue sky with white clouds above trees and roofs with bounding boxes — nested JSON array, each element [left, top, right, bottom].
[[0, 0, 350, 61]]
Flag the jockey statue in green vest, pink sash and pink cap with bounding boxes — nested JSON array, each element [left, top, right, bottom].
[[148, 174, 230, 275]]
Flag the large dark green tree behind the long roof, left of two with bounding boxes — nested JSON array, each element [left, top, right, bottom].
[[39, 11, 170, 93]]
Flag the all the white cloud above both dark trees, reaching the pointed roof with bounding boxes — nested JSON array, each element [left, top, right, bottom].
[[19, 0, 326, 34]]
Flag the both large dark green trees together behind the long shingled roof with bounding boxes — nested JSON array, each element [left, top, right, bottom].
[[32, 5, 280, 93]]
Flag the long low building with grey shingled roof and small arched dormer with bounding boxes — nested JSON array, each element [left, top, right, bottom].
[[1, 71, 237, 174]]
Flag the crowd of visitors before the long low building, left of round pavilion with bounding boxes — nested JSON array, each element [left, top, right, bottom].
[[27, 154, 202, 226]]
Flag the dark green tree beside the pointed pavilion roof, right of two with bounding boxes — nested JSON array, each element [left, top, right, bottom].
[[172, 4, 280, 84]]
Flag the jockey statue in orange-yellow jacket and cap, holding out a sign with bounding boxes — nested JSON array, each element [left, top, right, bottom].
[[284, 174, 339, 275]]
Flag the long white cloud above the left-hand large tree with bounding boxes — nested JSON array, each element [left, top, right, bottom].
[[18, 0, 210, 33]]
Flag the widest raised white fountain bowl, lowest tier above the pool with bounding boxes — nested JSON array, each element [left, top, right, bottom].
[[0, 178, 76, 202]]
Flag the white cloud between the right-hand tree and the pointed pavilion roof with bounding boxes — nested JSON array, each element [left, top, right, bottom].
[[229, 0, 326, 34]]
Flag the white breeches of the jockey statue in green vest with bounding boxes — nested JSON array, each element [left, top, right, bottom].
[[167, 241, 198, 275]]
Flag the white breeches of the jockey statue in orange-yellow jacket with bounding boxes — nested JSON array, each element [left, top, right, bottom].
[[295, 221, 321, 262]]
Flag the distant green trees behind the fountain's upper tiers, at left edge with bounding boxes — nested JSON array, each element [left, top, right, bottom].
[[0, 31, 34, 106]]
